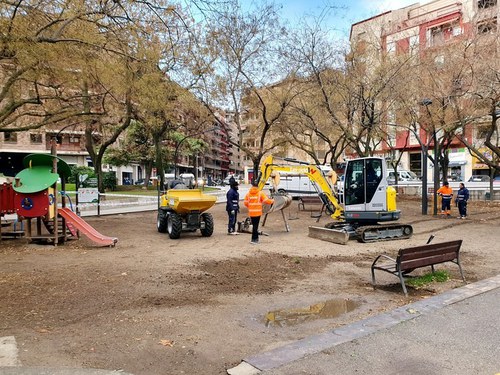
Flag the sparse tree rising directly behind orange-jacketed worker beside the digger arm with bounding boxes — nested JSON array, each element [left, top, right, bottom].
[[184, 1, 296, 179]]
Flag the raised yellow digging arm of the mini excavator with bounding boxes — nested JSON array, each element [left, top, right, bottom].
[[258, 155, 344, 220]]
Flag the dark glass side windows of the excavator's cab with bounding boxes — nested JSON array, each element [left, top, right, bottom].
[[344, 159, 382, 205]]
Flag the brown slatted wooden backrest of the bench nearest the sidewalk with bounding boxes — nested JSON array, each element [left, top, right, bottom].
[[396, 240, 462, 271]]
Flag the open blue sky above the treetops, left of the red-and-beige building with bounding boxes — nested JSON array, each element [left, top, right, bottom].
[[252, 0, 430, 37]]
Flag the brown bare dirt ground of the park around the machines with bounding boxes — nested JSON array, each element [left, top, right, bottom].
[[0, 199, 500, 375]]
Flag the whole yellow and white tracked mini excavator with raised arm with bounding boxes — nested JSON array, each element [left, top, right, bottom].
[[258, 155, 413, 244]]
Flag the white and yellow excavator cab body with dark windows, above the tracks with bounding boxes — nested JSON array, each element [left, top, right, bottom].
[[344, 157, 399, 223]]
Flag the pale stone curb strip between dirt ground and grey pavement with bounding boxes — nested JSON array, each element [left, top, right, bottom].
[[227, 275, 500, 375]]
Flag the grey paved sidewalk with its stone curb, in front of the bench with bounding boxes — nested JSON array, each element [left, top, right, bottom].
[[228, 275, 500, 375]]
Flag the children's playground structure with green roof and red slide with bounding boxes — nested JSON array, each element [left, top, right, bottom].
[[0, 142, 117, 246]]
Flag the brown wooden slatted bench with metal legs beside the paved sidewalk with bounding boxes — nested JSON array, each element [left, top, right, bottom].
[[371, 240, 465, 296]]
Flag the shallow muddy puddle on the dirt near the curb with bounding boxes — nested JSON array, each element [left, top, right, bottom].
[[265, 299, 360, 327]]
